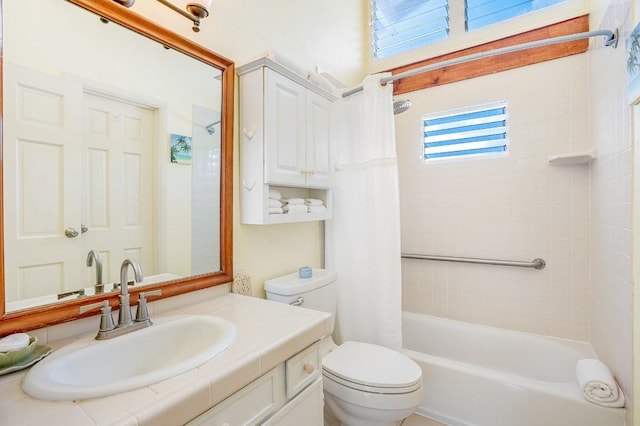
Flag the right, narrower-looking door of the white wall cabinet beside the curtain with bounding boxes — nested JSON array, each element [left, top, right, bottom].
[[305, 92, 333, 188]]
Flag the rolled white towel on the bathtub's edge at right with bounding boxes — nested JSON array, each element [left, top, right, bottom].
[[576, 358, 624, 407]]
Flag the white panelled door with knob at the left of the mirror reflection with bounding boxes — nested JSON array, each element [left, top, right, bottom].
[[3, 63, 83, 302]]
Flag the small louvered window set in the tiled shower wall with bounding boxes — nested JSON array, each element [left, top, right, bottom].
[[422, 102, 507, 160]]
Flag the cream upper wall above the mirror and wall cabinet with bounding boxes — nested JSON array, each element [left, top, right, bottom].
[[125, 0, 368, 86]]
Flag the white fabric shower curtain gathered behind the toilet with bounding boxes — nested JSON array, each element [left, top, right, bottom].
[[325, 74, 402, 349]]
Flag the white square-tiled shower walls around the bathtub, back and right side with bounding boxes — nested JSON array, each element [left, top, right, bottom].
[[396, 0, 633, 411]]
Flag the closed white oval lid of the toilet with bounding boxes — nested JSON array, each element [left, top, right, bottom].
[[322, 342, 422, 393]]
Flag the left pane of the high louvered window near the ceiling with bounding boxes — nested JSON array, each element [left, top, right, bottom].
[[371, 0, 449, 58]]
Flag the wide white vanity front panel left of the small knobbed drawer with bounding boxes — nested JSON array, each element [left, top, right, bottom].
[[188, 364, 285, 426]]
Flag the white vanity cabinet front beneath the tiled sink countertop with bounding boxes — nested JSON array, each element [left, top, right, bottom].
[[188, 343, 323, 426]]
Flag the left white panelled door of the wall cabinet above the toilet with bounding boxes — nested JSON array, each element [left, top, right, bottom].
[[264, 69, 306, 186]]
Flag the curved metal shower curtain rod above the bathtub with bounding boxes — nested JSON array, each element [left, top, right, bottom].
[[342, 28, 618, 98]]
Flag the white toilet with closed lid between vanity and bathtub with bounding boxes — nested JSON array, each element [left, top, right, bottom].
[[264, 269, 423, 426]]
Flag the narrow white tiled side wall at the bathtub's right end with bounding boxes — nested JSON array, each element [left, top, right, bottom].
[[589, 0, 633, 418]]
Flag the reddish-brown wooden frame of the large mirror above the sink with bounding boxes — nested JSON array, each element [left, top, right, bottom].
[[0, 0, 235, 336]]
